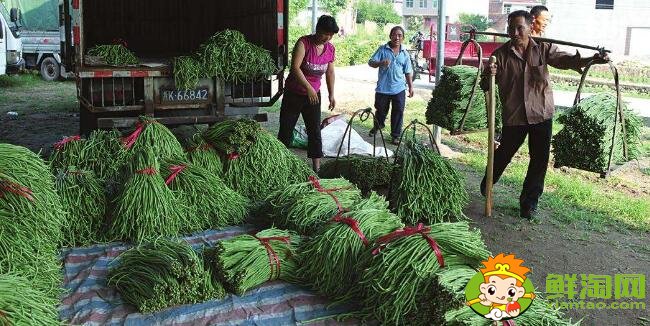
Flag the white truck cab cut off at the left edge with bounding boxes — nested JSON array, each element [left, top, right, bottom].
[[0, 3, 25, 75]]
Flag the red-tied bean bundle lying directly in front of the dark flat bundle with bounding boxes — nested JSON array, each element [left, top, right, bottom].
[[265, 177, 361, 235]]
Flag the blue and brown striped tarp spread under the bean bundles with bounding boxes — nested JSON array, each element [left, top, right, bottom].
[[59, 226, 354, 325]]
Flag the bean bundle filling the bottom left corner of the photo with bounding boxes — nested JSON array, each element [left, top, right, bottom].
[[0, 273, 63, 326]]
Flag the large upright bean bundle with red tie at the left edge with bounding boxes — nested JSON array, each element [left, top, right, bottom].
[[0, 144, 67, 298]]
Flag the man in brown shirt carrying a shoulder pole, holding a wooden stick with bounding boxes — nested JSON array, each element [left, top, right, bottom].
[[481, 10, 608, 219]]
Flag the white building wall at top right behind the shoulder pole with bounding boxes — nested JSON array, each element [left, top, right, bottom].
[[546, 0, 650, 56]]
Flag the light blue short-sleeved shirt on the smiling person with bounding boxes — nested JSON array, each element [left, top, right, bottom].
[[368, 43, 413, 95]]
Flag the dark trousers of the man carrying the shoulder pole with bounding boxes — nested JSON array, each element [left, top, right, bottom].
[[481, 119, 553, 210]]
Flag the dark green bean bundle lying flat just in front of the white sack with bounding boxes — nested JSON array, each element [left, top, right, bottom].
[[318, 155, 393, 193]]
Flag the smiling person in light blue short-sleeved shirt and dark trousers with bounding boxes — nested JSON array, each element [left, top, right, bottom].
[[368, 26, 413, 145]]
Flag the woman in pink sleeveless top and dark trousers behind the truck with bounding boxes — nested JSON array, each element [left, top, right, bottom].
[[278, 15, 339, 172]]
